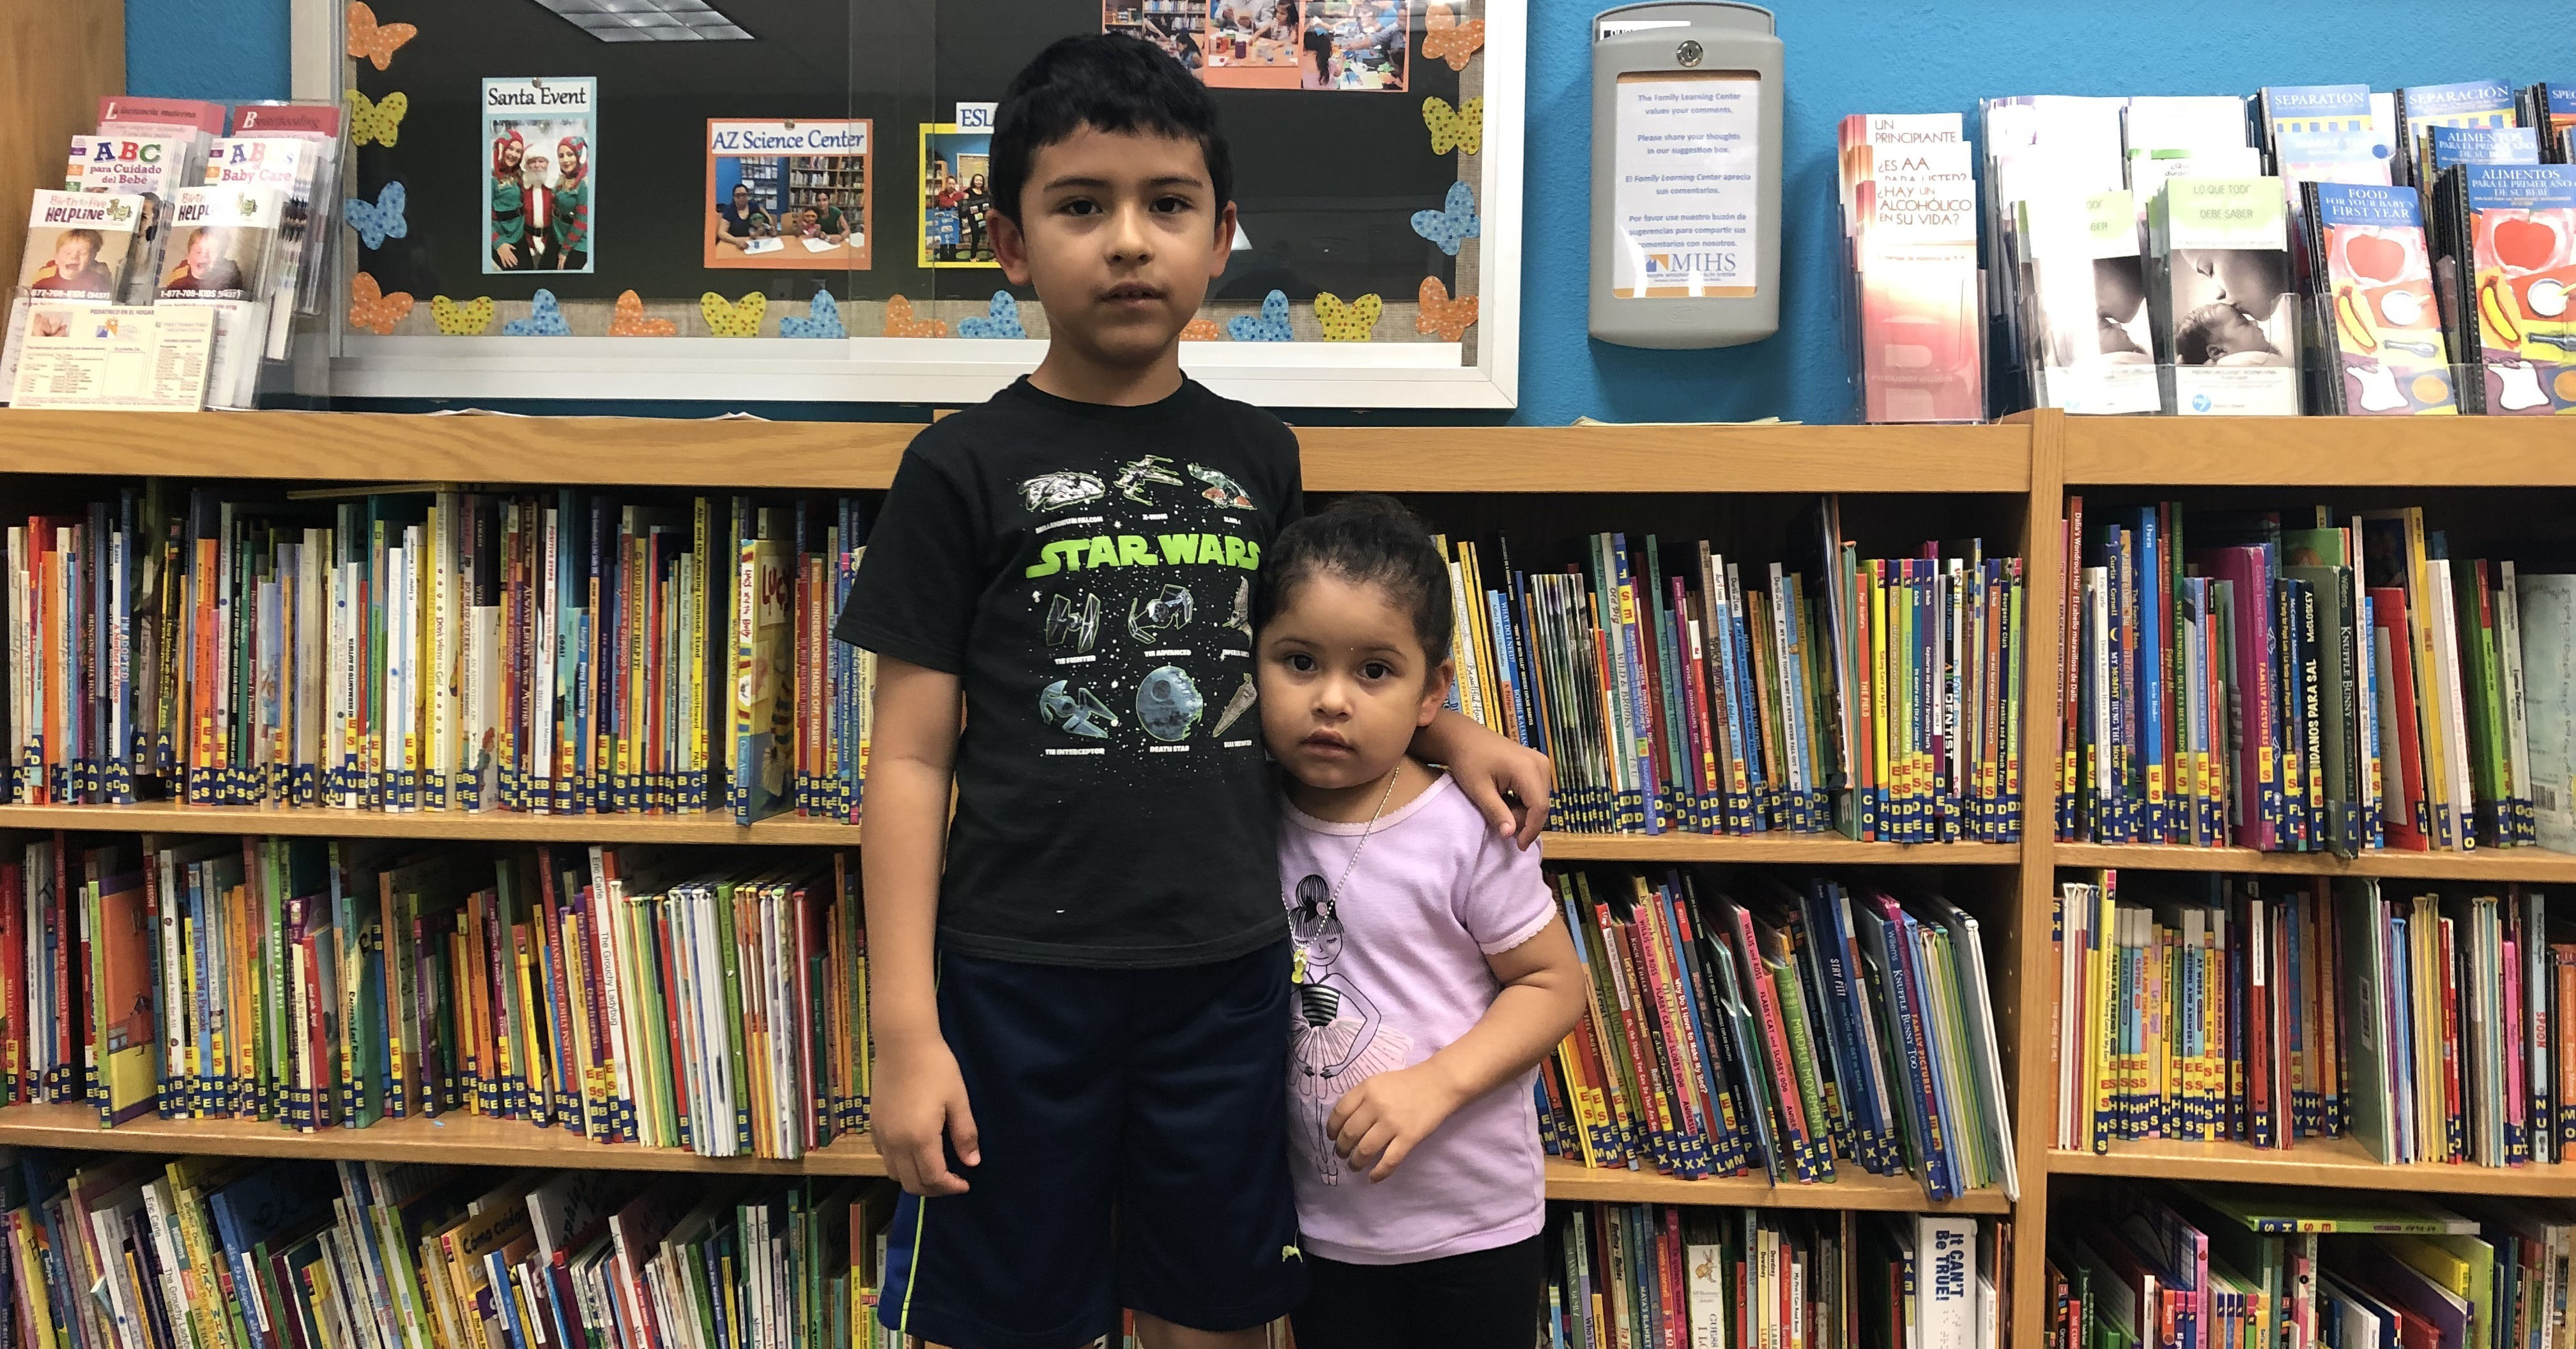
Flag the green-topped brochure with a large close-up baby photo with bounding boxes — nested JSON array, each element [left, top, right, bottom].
[[2149, 178, 2301, 417]]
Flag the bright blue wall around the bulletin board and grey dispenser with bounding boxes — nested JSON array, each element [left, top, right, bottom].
[[126, 0, 2576, 425]]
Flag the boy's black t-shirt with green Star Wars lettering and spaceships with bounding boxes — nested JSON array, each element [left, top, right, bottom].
[[834, 378, 1303, 965]]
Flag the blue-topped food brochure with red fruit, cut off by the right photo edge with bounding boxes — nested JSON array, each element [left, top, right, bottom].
[[2434, 165, 2576, 417]]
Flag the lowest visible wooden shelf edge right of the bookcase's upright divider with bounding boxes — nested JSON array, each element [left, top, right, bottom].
[[2048, 1138, 2576, 1200]]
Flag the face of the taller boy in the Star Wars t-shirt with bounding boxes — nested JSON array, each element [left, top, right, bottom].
[[992, 126, 1234, 365]]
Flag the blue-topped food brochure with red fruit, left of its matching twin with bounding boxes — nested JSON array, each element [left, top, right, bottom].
[[2303, 183, 2460, 417]]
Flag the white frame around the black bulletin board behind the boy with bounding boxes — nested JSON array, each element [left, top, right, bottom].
[[291, 0, 1528, 409]]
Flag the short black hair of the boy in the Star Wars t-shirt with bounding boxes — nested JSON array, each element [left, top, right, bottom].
[[984, 33, 1234, 224]]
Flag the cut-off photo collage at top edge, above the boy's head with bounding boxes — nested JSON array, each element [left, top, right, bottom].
[[1100, 0, 1414, 93]]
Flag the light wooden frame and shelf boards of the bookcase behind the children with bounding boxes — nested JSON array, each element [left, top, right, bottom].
[[15, 409, 2576, 1349]]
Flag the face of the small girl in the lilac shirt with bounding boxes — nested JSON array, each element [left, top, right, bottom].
[[1257, 572, 1450, 788]]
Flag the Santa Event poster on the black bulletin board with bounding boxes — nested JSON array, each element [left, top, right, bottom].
[[482, 75, 600, 275]]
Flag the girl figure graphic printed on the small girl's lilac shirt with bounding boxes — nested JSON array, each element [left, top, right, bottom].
[[1288, 875, 1414, 1184]]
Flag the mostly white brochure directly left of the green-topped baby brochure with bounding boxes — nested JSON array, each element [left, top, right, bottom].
[[2017, 190, 2164, 415]]
